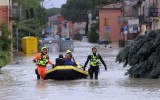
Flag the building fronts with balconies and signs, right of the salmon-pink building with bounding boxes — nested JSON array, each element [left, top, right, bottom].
[[121, 0, 160, 36]]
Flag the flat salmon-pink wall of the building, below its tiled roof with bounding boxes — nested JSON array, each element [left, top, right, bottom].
[[99, 8, 121, 43]]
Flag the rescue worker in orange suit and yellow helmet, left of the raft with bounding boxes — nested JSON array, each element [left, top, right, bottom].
[[33, 47, 54, 79]]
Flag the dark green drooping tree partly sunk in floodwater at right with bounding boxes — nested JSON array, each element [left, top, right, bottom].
[[116, 30, 160, 78]]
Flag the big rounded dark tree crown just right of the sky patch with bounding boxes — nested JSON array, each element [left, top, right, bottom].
[[61, 0, 91, 22]]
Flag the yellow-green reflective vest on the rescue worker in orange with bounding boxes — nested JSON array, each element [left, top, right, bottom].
[[36, 55, 49, 67]]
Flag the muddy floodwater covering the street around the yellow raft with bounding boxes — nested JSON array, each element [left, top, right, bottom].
[[0, 41, 160, 100]]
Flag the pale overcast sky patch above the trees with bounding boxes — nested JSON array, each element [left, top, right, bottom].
[[44, 0, 67, 8]]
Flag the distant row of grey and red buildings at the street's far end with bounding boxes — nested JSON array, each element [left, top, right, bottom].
[[48, 14, 86, 40]]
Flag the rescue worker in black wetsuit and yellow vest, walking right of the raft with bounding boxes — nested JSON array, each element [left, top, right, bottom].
[[83, 47, 107, 79]]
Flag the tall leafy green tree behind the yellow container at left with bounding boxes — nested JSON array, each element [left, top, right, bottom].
[[13, 0, 42, 51]]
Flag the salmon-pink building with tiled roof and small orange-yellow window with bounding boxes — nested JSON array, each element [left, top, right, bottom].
[[99, 3, 122, 43]]
